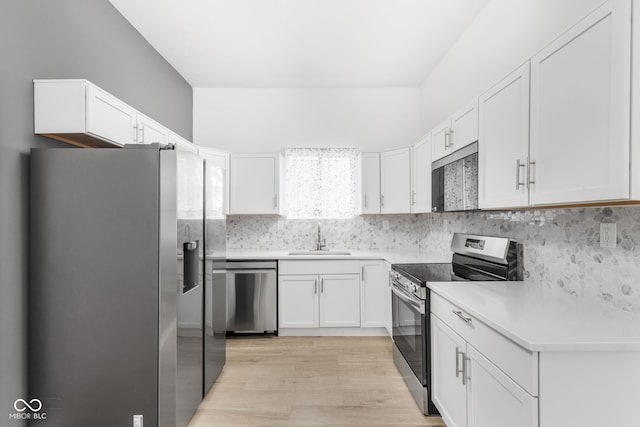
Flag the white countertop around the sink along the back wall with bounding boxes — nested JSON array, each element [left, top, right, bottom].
[[227, 249, 451, 264]]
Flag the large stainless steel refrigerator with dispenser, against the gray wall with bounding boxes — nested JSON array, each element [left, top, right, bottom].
[[28, 144, 226, 427]]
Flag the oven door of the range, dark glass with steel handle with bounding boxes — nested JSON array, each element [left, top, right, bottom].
[[391, 280, 428, 387]]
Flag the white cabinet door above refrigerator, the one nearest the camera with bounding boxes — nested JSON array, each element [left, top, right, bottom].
[[86, 84, 137, 145]]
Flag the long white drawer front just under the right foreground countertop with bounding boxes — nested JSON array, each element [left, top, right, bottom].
[[431, 292, 538, 396]]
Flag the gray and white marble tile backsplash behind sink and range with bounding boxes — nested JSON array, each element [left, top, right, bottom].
[[227, 206, 640, 314]]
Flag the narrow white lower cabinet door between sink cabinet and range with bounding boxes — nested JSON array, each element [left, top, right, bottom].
[[360, 261, 391, 328]]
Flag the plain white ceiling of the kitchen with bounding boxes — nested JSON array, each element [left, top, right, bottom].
[[110, 0, 488, 87]]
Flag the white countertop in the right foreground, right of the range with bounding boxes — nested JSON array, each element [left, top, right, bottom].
[[428, 282, 640, 351]]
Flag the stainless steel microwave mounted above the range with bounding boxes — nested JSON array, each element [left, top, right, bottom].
[[431, 142, 478, 212]]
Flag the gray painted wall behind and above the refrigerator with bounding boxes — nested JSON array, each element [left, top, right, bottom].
[[0, 0, 193, 426]]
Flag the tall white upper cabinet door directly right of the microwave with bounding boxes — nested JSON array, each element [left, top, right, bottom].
[[478, 61, 529, 209]]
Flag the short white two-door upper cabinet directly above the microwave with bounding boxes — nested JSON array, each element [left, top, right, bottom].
[[431, 98, 478, 161]]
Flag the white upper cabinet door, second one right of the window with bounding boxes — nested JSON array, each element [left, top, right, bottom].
[[380, 148, 411, 213]]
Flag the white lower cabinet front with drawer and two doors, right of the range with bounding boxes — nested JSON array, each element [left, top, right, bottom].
[[431, 294, 538, 427]]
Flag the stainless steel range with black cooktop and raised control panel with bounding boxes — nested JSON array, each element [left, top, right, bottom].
[[390, 233, 521, 415]]
